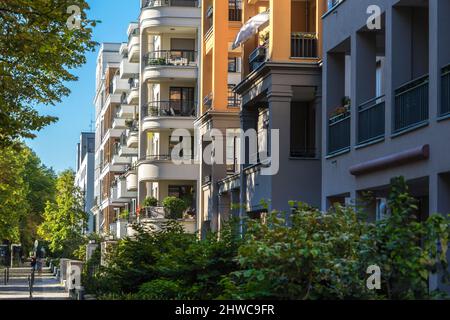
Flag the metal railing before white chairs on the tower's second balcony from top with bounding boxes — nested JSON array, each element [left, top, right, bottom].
[[144, 50, 197, 66]]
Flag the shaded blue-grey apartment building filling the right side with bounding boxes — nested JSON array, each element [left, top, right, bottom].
[[322, 0, 450, 287]]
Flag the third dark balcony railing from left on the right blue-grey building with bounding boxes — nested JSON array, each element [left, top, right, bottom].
[[394, 75, 428, 133]]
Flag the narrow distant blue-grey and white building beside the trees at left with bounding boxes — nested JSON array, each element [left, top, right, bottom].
[[75, 132, 95, 233]]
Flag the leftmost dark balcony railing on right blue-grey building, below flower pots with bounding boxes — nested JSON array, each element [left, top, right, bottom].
[[328, 111, 350, 154]]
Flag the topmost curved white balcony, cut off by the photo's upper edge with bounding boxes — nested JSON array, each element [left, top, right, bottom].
[[140, 0, 201, 32]]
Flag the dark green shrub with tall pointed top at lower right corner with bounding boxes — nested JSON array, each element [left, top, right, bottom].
[[362, 177, 450, 299]]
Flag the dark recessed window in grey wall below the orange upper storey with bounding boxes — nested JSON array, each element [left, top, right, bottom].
[[291, 103, 316, 158]]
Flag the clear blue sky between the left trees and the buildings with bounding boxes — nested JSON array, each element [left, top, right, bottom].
[[26, 0, 140, 172]]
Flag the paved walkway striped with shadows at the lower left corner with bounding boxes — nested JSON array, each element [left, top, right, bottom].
[[0, 269, 69, 300]]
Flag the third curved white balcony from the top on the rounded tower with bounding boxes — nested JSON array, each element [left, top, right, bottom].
[[142, 100, 196, 130]]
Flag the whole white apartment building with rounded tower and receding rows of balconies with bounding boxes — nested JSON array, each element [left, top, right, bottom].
[[93, 0, 201, 238]]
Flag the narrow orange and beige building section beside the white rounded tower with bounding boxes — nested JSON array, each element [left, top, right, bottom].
[[195, 0, 242, 233]]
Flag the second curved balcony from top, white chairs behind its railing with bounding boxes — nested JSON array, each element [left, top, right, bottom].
[[144, 50, 198, 81]]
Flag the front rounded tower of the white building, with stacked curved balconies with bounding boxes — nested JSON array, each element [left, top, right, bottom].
[[125, 0, 200, 232]]
